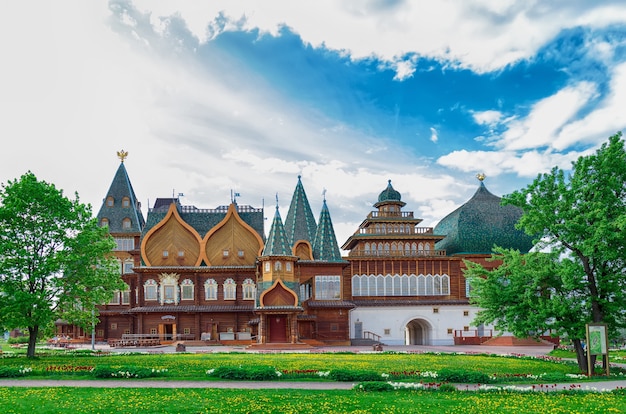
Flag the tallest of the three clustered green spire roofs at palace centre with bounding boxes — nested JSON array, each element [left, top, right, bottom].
[[285, 176, 317, 246]]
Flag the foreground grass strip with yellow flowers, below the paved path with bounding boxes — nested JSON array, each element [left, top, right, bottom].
[[0, 387, 626, 414]]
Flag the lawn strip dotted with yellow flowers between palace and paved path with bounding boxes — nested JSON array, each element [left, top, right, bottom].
[[0, 352, 579, 381]]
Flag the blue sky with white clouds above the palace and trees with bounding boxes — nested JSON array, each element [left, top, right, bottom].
[[0, 0, 626, 246]]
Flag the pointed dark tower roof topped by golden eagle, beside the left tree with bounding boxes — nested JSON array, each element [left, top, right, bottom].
[[97, 151, 146, 233]]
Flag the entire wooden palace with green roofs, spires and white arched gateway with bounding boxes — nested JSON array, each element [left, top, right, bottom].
[[57, 152, 532, 347]]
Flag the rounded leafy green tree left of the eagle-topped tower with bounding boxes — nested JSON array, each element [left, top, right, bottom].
[[0, 171, 123, 357]]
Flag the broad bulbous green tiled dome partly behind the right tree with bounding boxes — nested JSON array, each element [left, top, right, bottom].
[[434, 182, 533, 255]]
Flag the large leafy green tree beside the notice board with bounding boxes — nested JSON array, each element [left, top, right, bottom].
[[466, 133, 626, 371]]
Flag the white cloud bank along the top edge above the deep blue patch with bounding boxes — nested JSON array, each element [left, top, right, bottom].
[[134, 0, 626, 73]]
